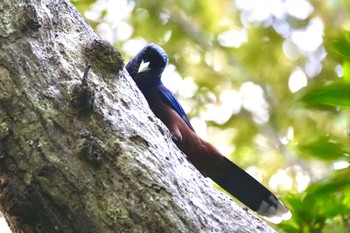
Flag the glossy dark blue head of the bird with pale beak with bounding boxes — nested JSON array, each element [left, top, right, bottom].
[[126, 44, 168, 87]]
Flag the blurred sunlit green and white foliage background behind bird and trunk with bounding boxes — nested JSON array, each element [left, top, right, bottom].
[[2, 0, 350, 232]]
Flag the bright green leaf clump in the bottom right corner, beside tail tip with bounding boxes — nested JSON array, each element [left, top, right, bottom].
[[280, 169, 350, 232]]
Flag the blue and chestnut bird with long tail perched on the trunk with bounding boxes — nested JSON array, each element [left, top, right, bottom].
[[125, 43, 291, 223]]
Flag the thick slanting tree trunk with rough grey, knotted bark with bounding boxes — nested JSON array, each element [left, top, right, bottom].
[[0, 0, 273, 233]]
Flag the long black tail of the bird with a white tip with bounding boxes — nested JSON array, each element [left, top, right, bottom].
[[210, 158, 291, 223]]
